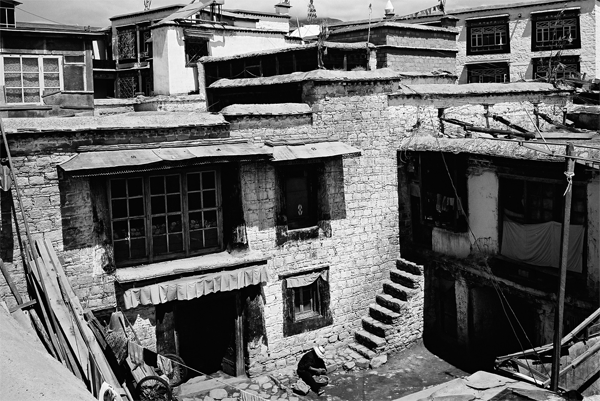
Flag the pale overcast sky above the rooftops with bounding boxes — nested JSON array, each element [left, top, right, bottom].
[[17, 0, 523, 27]]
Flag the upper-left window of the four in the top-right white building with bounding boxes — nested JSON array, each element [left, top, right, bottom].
[[467, 16, 510, 56]]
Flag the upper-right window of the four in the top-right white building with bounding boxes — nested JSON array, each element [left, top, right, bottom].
[[531, 9, 581, 51]]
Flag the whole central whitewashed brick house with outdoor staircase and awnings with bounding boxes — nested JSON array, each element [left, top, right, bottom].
[[0, 62, 584, 375]]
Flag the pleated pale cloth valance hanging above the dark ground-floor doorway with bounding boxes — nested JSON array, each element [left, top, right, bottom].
[[123, 265, 268, 309]]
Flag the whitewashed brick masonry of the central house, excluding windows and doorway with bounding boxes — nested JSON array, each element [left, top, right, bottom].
[[0, 71, 568, 375]]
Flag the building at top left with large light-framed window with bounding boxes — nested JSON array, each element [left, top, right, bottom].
[[0, 0, 103, 117]]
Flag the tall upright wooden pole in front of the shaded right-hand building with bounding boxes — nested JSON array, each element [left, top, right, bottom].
[[550, 142, 575, 391]]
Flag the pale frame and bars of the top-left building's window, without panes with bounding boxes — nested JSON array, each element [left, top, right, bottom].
[[0, 54, 64, 104]]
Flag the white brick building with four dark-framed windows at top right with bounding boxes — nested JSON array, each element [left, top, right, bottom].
[[396, 0, 600, 84]]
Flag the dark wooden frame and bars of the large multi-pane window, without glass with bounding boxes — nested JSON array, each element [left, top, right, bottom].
[[107, 167, 223, 267]]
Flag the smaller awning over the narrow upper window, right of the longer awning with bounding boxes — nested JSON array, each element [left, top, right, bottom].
[[273, 142, 361, 162]]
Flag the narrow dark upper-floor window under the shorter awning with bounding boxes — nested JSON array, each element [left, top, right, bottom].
[[281, 164, 319, 230]]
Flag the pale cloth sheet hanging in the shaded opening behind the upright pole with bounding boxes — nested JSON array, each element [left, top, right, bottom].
[[500, 219, 585, 273]]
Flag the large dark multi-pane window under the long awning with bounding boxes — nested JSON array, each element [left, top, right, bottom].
[[109, 170, 222, 266]]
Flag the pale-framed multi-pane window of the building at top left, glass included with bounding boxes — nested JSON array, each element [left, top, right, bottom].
[[3, 55, 63, 103]]
